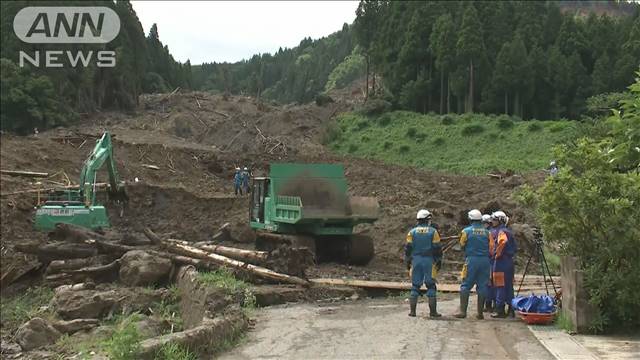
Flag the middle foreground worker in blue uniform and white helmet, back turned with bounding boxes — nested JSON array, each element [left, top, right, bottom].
[[454, 209, 491, 320]]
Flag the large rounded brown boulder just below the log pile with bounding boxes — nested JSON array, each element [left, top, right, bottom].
[[120, 250, 172, 286]]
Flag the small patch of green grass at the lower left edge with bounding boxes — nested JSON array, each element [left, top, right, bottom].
[[0, 286, 53, 332]]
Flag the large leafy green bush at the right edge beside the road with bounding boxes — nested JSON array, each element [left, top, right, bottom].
[[538, 71, 640, 331]]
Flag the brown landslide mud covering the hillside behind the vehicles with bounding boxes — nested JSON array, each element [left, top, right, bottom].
[[0, 88, 543, 288]]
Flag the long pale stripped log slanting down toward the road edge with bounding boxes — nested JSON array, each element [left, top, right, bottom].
[[164, 242, 309, 286]]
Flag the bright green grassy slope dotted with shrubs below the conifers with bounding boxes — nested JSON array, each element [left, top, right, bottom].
[[326, 111, 577, 175]]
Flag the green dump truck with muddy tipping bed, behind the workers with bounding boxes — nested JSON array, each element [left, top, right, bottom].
[[249, 163, 379, 265]]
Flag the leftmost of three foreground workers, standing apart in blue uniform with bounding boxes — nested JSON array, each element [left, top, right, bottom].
[[404, 209, 442, 318]]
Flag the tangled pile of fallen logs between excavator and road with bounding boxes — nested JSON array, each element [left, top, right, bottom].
[[16, 224, 309, 286]]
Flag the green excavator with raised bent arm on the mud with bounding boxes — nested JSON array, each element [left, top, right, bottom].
[[34, 132, 127, 231]]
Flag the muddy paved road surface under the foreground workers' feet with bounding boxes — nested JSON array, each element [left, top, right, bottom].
[[222, 298, 553, 360]]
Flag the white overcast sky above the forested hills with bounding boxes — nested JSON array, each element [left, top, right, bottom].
[[132, 1, 358, 65]]
